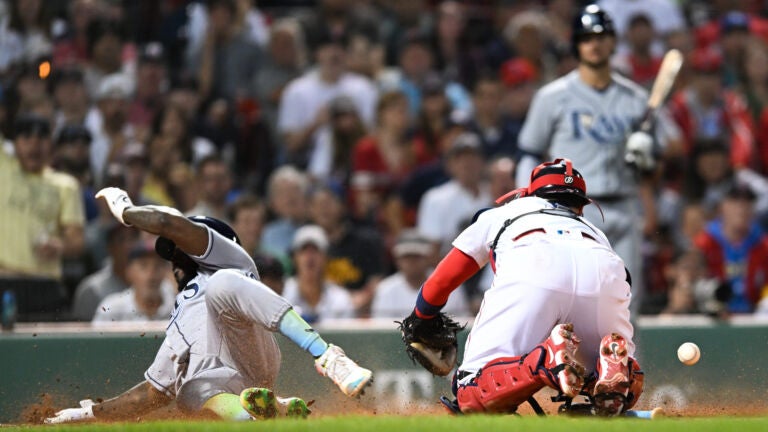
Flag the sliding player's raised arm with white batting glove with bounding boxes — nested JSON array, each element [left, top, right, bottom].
[[96, 187, 208, 256]]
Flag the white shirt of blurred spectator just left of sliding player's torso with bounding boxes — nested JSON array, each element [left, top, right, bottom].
[[93, 281, 176, 324]]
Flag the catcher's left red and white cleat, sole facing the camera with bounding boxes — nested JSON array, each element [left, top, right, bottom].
[[544, 323, 585, 398]]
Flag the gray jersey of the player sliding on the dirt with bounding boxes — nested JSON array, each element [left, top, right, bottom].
[[144, 227, 259, 397]]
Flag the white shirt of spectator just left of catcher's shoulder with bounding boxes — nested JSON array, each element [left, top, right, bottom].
[[417, 180, 493, 253]]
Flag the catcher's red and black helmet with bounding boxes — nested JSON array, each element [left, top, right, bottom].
[[496, 158, 592, 208]]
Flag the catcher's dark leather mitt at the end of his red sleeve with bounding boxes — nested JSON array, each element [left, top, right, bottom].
[[395, 312, 464, 376]]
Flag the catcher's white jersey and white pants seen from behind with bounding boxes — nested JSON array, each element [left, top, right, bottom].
[[453, 197, 634, 372]]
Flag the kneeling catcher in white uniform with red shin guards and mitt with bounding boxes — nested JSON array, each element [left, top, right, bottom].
[[401, 159, 643, 415]]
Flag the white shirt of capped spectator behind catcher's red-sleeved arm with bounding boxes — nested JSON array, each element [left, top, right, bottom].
[[371, 272, 469, 318]]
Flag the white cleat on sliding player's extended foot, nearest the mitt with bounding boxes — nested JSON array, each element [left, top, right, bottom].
[[315, 344, 373, 397]]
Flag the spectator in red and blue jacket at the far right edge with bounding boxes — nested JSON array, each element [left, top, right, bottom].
[[694, 183, 768, 313]]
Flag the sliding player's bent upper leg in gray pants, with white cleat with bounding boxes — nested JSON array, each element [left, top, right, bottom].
[[206, 270, 372, 397]]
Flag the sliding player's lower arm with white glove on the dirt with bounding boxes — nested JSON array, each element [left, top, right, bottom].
[[45, 381, 172, 424]]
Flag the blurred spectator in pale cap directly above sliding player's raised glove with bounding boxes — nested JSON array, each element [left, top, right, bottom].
[[85, 74, 135, 186]]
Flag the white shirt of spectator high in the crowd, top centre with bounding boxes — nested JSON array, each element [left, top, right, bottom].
[[277, 70, 379, 134]]
